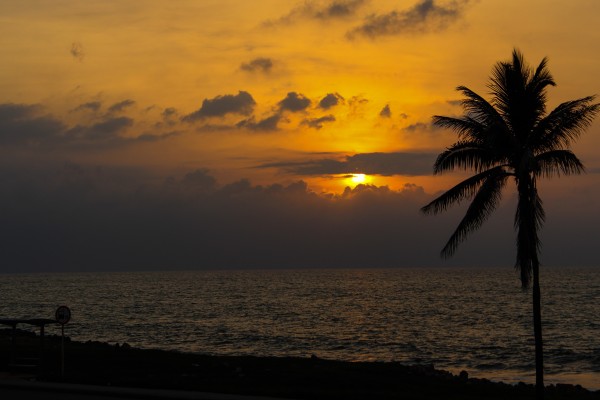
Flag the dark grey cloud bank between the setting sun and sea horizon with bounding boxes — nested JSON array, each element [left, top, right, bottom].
[[0, 162, 600, 272]]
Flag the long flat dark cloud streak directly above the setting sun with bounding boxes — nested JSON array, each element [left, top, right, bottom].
[[256, 152, 437, 176]]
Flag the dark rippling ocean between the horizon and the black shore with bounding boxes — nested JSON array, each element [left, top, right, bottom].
[[0, 267, 600, 390]]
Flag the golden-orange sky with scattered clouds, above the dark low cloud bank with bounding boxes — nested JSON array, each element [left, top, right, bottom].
[[0, 0, 600, 272]]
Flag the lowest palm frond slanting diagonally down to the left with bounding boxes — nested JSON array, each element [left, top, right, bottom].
[[441, 168, 509, 258]]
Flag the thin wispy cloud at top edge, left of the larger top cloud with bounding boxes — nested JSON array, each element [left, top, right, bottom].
[[263, 0, 368, 26]]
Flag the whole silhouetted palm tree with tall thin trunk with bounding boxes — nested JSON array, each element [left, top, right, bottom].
[[421, 49, 600, 399]]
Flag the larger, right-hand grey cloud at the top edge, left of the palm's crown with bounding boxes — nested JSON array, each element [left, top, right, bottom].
[[346, 0, 469, 39]]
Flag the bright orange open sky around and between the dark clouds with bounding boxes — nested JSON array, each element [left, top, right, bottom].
[[0, 0, 600, 190]]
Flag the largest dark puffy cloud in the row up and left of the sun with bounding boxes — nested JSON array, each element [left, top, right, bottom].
[[182, 91, 256, 122]]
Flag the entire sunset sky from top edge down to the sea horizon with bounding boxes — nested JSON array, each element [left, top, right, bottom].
[[0, 0, 600, 272]]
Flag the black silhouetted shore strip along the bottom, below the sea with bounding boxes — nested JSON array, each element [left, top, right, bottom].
[[0, 331, 600, 400]]
